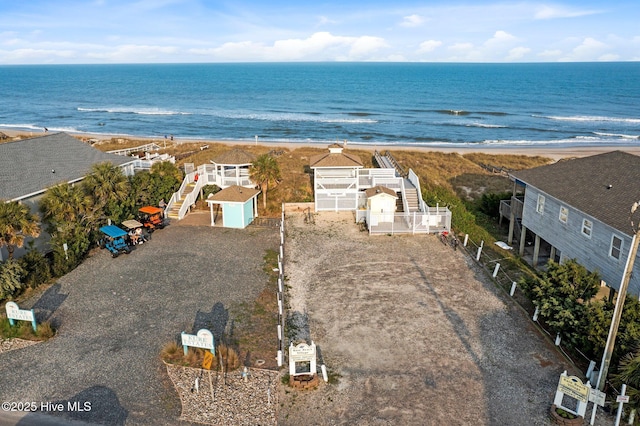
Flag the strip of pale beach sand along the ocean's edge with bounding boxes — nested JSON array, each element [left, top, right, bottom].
[[0, 129, 640, 160]]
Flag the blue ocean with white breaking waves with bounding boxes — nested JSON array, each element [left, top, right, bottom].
[[0, 62, 640, 147]]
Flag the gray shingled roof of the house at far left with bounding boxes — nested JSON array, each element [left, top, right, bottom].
[[0, 133, 132, 200]]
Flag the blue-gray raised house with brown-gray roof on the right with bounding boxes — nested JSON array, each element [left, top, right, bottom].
[[500, 151, 640, 296]]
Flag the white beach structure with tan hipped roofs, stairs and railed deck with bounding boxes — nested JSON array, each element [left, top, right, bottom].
[[309, 143, 451, 234]]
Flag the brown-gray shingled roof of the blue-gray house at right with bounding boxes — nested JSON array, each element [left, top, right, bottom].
[[512, 151, 640, 235]]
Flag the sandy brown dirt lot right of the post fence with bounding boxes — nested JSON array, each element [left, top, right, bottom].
[[279, 213, 568, 425]]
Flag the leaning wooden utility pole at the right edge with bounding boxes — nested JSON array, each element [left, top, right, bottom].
[[591, 202, 640, 425]]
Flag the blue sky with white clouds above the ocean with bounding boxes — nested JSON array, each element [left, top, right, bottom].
[[0, 0, 640, 65]]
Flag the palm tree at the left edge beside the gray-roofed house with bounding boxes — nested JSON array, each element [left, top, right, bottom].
[[0, 201, 40, 259]]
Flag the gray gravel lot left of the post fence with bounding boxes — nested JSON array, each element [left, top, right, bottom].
[[0, 225, 279, 425]]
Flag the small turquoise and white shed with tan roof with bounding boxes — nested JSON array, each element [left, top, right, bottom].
[[207, 185, 260, 228]]
